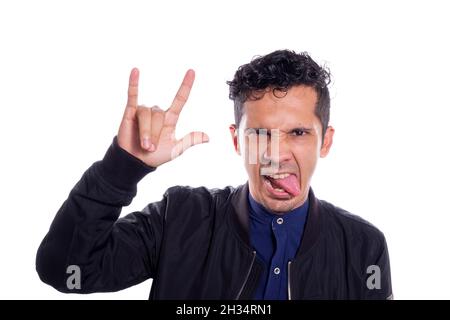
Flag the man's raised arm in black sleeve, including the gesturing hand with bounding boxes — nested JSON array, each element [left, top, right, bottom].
[[36, 69, 208, 293]]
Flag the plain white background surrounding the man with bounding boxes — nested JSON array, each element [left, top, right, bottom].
[[0, 0, 450, 299]]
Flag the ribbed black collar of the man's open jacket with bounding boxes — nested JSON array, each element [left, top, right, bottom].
[[230, 182, 321, 256]]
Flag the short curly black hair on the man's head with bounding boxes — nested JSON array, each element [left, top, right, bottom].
[[227, 50, 330, 140]]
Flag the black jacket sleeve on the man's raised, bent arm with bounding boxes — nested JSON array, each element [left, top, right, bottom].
[[36, 137, 166, 293]]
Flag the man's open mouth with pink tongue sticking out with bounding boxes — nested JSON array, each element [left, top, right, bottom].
[[262, 173, 300, 198]]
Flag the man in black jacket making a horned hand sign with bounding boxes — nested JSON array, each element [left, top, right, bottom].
[[36, 50, 392, 299]]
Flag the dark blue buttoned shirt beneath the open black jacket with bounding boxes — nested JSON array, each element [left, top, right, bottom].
[[248, 192, 309, 300]]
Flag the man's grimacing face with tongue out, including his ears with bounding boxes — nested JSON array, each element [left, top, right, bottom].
[[230, 86, 334, 214]]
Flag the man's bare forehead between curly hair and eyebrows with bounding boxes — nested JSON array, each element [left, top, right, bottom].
[[242, 85, 319, 128]]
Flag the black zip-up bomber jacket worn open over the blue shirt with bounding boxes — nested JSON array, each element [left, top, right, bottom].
[[36, 139, 392, 299]]
